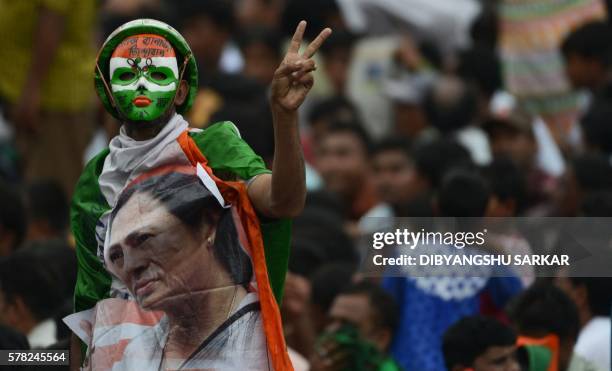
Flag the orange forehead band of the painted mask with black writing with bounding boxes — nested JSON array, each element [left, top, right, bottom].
[[111, 34, 176, 58]]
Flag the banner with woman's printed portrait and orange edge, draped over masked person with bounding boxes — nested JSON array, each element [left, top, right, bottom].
[[65, 131, 292, 371]]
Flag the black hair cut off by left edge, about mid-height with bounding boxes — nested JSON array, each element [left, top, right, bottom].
[[0, 181, 28, 250]]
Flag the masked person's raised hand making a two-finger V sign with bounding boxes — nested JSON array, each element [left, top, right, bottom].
[[271, 21, 332, 111]]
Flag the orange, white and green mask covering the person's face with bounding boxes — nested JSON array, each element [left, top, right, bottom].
[[110, 34, 179, 121]]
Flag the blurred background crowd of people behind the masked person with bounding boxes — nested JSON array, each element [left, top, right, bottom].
[[0, 0, 612, 371]]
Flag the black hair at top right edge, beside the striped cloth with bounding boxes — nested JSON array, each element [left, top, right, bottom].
[[561, 21, 612, 66]]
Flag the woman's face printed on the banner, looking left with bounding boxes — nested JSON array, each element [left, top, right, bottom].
[[106, 193, 218, 310]]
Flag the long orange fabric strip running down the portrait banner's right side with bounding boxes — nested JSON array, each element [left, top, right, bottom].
[[177, 131, 293, 371]]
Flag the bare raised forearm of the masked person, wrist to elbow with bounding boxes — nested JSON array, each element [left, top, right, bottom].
[[270, 109, 306, 217]]
